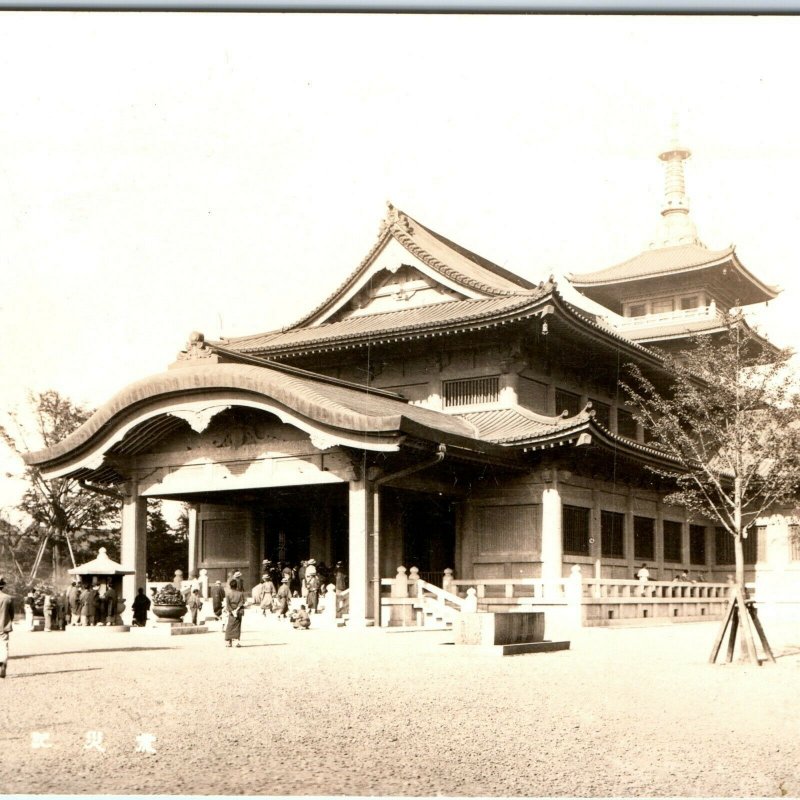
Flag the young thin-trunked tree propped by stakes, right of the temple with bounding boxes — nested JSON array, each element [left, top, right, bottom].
[[623, 316, 800, 664]]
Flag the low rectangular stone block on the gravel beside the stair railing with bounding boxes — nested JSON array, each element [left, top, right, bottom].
[[453, 611, 569, 655]]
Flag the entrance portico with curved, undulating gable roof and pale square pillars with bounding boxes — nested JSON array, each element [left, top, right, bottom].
[[28, 341, 520, 625]]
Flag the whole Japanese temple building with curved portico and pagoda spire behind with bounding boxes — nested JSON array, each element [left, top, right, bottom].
[[21, 136, 800, 624]]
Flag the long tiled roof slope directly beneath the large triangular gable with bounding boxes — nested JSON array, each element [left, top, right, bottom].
[[218, 292, 553, 353]]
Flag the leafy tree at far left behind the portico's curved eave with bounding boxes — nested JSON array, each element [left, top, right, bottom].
[[0, 389, 121, 582]]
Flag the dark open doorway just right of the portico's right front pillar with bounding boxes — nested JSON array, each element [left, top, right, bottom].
[[398, 492, 456, 586]]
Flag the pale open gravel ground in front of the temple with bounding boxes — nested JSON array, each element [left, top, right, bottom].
[[0, 615, 800, 797]]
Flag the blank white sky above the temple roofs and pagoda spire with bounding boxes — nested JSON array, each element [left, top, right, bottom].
[[0, 12, 800, 507]]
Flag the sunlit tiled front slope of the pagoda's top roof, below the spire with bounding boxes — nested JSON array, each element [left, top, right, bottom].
[[567, 244, 734, 289]]
